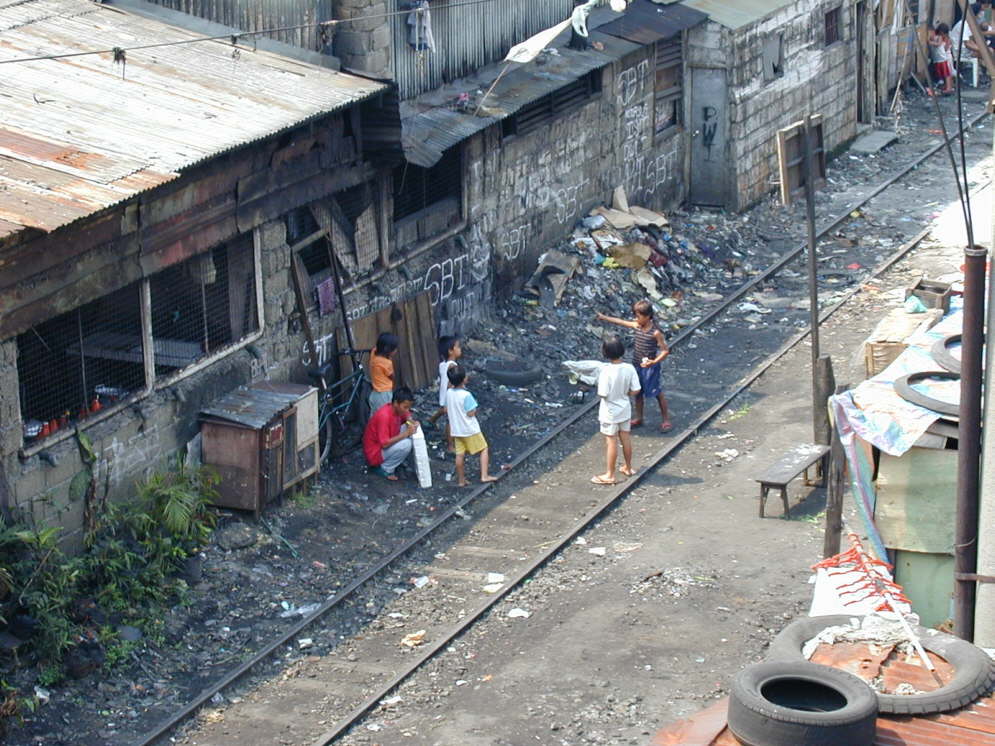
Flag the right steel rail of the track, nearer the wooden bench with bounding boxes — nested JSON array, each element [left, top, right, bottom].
[[312, 218, 948, 746]]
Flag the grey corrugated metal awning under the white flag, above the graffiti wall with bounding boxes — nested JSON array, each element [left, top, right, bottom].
[[401, 31, 640, 168]]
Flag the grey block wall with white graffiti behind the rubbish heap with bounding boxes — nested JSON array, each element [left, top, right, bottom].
[[463, 46, 686, 286]]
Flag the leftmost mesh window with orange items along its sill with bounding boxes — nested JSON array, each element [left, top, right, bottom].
[[17, 282, 145, 445]]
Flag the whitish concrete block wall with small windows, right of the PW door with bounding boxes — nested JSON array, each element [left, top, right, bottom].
[[726, 0, 857, 210]]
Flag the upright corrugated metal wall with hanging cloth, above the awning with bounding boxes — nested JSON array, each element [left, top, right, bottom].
[[389, 0, 573, 99]]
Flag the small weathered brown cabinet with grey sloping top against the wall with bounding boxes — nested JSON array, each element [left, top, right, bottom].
[[200, 382, 318, 516]]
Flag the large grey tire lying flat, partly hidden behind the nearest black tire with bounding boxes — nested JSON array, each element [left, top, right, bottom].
[[767, 614, 995, 715]]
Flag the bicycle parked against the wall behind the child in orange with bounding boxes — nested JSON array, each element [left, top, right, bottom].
[[308, 349, 370, 464]]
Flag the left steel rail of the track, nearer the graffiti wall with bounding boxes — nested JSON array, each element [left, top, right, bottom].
[[135, 106, 987, 746]]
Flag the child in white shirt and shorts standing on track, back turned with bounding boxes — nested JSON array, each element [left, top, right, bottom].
[[591, 337, 642, 484]]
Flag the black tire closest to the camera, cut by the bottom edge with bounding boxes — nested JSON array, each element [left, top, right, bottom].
[[728, 661, 878, 746]]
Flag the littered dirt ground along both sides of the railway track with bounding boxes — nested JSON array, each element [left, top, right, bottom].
[[9, 90, 991, 745]]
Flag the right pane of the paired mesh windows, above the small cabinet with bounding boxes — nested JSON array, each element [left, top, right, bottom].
[[149, 239, 259, 376]]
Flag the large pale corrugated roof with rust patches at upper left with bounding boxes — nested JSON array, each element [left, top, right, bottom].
[[0, 0, 386, 237]]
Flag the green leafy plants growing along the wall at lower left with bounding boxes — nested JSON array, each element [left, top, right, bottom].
[[0, 462, 218, 733]]
